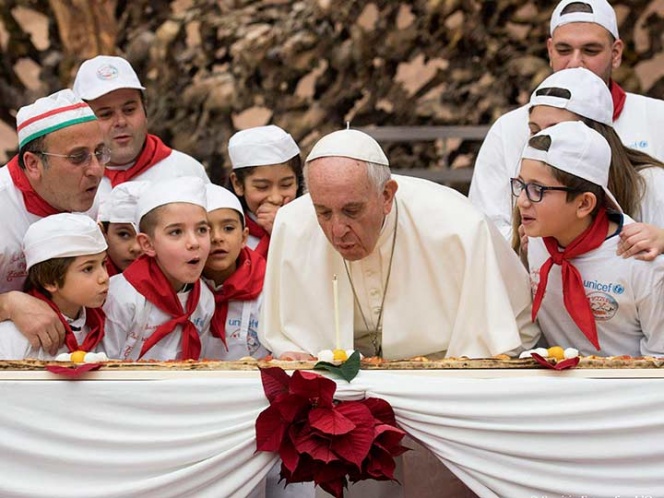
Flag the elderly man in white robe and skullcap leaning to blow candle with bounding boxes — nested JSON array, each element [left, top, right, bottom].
[[259, 130, 539, 359]]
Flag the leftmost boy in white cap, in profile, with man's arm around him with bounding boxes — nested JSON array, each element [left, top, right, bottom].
[[0, 213, 108, 360]]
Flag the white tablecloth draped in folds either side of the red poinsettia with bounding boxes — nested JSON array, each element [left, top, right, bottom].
[[0, 371, 664, 498]]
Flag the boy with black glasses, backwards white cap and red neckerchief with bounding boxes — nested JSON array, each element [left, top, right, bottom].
[[511, 121, 664, 356]]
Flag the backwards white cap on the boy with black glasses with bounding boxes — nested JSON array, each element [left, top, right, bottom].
[[521, 121, 623, 213]]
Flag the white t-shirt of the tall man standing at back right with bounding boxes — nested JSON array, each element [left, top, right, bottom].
[[468, 93, 664, 240]]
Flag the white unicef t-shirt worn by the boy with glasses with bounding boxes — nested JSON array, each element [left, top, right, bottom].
[[528, 216, 664, 356]]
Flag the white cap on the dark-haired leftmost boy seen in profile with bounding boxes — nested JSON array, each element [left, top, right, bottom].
[[23, 213, 108, 270]]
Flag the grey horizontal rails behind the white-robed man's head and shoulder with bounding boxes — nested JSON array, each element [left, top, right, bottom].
[[360, 125, 489, 185]]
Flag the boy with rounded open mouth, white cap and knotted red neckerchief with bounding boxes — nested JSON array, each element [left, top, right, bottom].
[[104, 177, 214, 360]]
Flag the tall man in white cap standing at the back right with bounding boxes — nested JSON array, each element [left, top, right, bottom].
[[469, 0, 664, 238]]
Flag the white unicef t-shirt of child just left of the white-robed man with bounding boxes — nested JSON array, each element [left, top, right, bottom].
[[204, 279, 270, 361]]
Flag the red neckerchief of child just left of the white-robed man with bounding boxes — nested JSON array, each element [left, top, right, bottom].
[[210, 247, 265, 350]]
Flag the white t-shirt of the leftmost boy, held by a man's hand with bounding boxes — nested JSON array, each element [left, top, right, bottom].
[[0, 308, 104, 360]]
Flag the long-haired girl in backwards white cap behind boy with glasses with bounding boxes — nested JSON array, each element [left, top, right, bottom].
[[514, 68, 664, 259]]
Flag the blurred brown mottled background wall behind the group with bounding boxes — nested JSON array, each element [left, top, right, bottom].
[[0, 0, 664, 182]]
